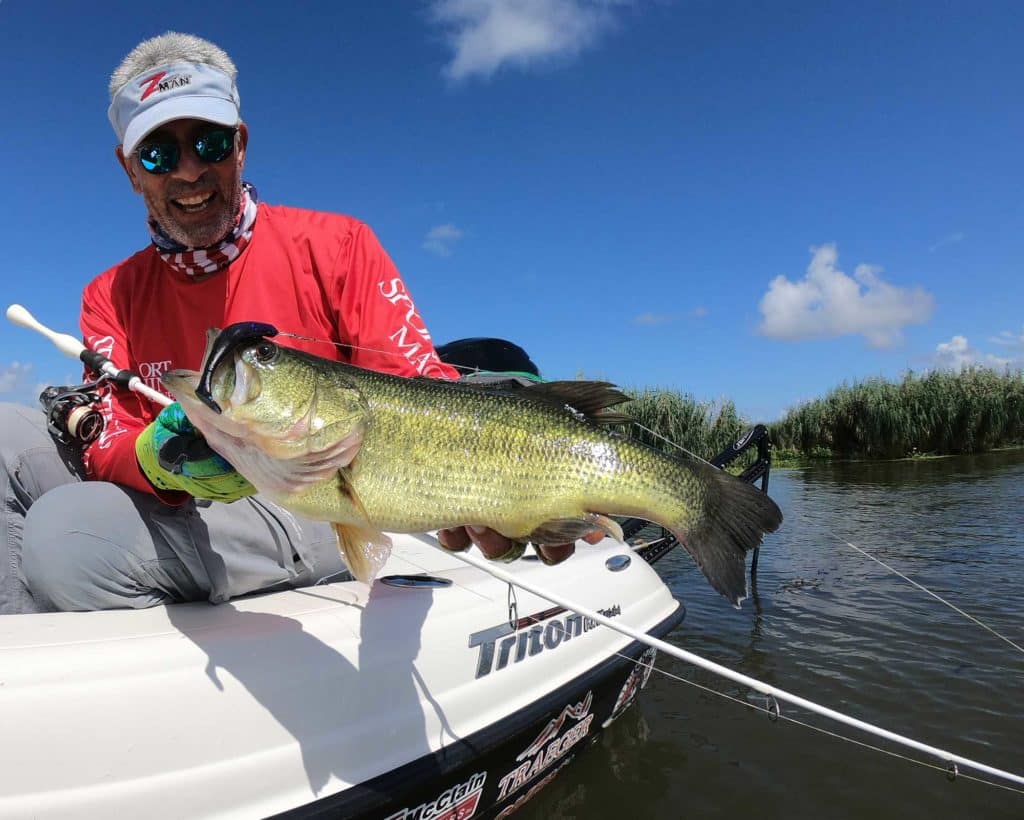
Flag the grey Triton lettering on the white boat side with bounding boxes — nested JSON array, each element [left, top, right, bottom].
[[469, 604, 623, 678]]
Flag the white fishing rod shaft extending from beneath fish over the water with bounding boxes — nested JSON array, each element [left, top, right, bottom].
[[415, 533, 1024, 786]]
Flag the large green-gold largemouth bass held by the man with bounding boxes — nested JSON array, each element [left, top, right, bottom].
[[163, 322, 782, 605]]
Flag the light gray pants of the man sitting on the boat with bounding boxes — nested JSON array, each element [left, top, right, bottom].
[[0, 403, 345, 614]]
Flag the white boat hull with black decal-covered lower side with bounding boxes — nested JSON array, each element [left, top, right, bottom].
[[0, 535, 682, 820]]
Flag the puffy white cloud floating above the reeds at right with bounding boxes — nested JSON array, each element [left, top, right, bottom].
[[760, 245, 935, 347]]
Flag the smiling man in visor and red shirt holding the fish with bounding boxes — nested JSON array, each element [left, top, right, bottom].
[[0, 33, 581, 613]]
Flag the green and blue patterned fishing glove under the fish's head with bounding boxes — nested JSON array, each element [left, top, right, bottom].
[[135, 401, 256, 503]]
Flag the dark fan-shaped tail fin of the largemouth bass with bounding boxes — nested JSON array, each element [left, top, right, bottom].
[[669, 464, 782, 608]]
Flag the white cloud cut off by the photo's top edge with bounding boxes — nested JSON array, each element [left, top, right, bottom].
[[431, 0, 629, 81]]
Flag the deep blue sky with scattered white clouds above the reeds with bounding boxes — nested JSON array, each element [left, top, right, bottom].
[[0, 0, 1024, 421]]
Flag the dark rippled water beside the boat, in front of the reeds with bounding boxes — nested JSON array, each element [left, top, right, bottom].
[[517, 450, 1024, 820]]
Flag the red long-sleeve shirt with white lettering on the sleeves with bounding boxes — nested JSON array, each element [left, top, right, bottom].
[[81, 204, 458, 502]]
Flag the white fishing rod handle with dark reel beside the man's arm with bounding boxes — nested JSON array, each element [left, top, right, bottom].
[[7, 305, 171, 446]]
